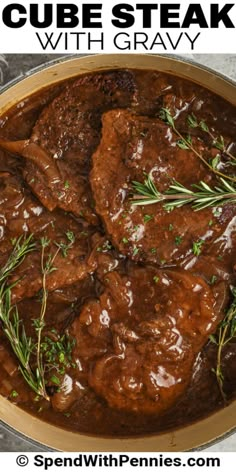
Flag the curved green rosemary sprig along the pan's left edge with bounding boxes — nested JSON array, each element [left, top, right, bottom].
[[0, 235, 49, 399]]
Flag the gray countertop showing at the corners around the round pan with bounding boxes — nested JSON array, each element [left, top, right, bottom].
[[0, 54, 236, 452]]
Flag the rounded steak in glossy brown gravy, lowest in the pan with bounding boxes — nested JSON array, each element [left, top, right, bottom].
[[70, 264, 220, 414]]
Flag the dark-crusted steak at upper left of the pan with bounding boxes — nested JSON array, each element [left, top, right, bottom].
[[0, 70, 135, 224]]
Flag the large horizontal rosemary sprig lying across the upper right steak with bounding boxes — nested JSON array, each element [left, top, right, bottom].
[[131, 175, 236, 211]]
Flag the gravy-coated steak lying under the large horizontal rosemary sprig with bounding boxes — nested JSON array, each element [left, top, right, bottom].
[[90, 110, 235, 265]]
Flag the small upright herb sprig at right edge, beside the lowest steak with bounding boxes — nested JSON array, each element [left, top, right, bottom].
[[210, 288, 236, 401]]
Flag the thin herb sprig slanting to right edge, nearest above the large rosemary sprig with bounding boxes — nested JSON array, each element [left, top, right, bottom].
[[159, 108, 236, 182]]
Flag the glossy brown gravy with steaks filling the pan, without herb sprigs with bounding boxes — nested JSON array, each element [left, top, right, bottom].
[[0, 70, 236, 436]]
